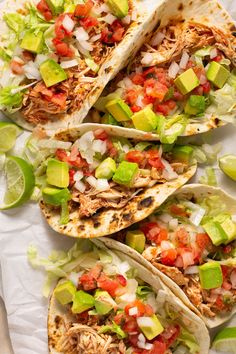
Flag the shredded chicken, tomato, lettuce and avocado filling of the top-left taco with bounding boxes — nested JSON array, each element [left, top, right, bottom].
[[0, 0, 132, 125]]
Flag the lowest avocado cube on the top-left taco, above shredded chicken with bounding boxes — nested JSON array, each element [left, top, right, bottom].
[[39, 59, 67, 87]]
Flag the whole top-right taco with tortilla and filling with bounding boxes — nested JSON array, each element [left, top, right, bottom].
[[86, 0, 236, 143]]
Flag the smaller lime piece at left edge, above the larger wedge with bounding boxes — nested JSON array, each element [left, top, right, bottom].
[[0, 122, 22, 152]]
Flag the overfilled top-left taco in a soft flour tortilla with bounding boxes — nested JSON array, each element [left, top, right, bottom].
[[0, 0, 158, 130]]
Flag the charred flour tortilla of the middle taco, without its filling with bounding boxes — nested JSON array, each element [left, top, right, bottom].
[[40, 124, 196, 238]]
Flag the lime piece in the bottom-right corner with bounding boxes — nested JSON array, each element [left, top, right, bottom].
[[212, 327, 236, 354]]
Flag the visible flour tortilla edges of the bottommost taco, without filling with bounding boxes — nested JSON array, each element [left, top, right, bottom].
[[48, 240, 210, 354]]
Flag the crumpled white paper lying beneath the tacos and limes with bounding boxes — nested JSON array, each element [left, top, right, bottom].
[[0, 0, 236, 354]]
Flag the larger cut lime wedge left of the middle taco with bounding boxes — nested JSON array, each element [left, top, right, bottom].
[[0, 156, 35, 210]]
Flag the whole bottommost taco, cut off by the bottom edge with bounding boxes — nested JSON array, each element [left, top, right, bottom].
[[48, 241, 209, 354]]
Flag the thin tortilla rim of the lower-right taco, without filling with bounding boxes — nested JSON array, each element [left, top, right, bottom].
[[102, 184, 236, 328]]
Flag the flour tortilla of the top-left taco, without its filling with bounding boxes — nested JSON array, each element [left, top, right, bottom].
[[0, 0, 163, 135]]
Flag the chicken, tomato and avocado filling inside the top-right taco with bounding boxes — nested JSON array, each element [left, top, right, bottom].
[[92, 22, 236, 143]]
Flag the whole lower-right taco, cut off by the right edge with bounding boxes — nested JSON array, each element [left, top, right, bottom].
[[104, 184, 236, 327]]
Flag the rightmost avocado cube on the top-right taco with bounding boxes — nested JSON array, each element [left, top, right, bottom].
[[206, 61, 230, 88]]
